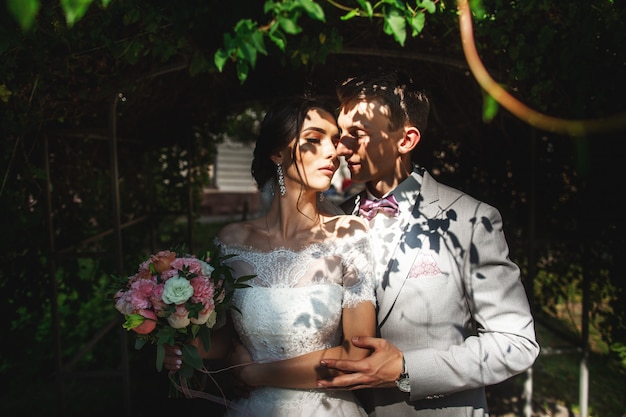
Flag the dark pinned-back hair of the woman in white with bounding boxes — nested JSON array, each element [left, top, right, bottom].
[[251, 97, 335, 189]]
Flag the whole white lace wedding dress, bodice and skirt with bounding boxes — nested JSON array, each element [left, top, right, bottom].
[[216, 231, 375, 417]]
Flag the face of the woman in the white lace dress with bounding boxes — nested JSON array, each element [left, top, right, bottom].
[[284, 109, 339, 191]]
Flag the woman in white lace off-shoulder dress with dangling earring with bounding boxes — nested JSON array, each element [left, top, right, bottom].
[[164, 99, 376, 417]]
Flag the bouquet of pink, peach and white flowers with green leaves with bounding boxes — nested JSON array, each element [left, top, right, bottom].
[[114, 245, 252, 381]]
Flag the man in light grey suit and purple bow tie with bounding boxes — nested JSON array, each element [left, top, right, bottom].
[[319, 73, 539, 417]]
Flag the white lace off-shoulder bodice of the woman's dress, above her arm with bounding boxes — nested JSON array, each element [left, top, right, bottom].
[[216, 231, 375, 361]]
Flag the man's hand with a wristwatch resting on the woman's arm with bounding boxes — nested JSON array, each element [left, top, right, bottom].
[[318, 336, 402, 390]]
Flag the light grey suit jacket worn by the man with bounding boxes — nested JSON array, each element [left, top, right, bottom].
[[343, 168, 539, 417]]
